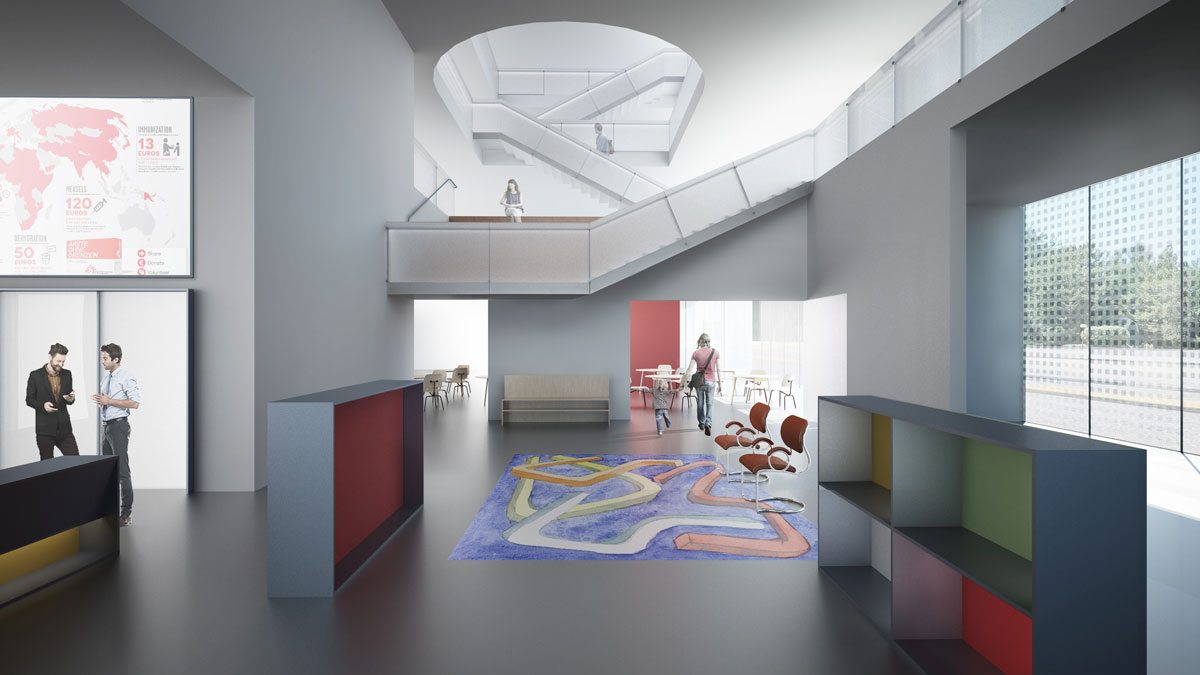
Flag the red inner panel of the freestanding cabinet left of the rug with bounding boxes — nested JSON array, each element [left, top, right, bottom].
[[334, 389, 404, 563]]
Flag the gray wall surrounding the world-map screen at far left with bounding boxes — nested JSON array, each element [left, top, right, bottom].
[[0, 0, 254, 490]]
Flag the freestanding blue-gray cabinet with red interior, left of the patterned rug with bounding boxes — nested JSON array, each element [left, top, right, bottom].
[[266, 380, 425, 597]]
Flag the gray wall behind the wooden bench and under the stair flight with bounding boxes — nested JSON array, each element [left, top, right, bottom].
[[487, 199, 808, 419]]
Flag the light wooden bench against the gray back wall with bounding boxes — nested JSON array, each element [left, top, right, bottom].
[[500, 375, 611, 424]]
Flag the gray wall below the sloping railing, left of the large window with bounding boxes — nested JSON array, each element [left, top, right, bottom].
[[809, 0, 1163, 410]]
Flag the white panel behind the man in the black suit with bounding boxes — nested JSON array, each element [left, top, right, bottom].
[[0, 292, 100, 468]]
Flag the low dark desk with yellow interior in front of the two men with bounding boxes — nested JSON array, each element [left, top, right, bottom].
[[0, 455, 120, 605]]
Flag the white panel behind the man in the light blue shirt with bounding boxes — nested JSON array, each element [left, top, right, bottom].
[[99, 291, 188, 490]]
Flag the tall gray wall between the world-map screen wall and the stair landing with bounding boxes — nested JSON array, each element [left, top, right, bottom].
[[126, 0, 420, 488]]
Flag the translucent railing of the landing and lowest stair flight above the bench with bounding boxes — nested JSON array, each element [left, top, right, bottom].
[[388, 133, 812, 294]]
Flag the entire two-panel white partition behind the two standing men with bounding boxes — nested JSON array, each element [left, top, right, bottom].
[[0, 291, 191, 482]]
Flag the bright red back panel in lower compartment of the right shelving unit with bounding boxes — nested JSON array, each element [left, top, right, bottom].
[[962, 577, 1033, 675]]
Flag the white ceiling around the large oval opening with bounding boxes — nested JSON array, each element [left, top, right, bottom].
[[393, 0, 949, 181]]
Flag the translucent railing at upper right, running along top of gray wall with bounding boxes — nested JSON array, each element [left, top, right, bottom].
[[816, 0, 1072, 170]]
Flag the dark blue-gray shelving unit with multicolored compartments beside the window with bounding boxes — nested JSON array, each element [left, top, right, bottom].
[[817, 396, 1146, 674]]
